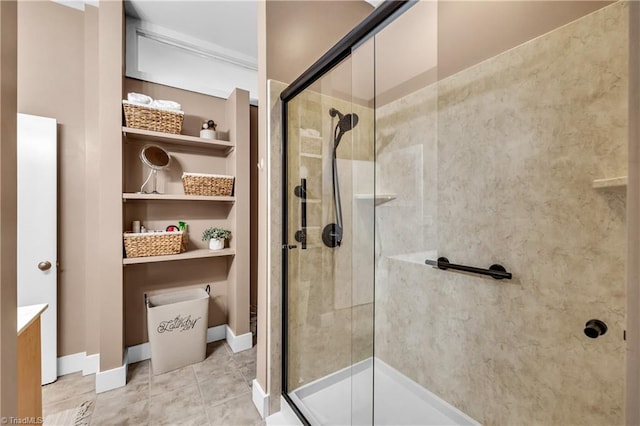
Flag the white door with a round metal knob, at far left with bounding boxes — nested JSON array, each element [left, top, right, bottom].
[[18, 114, 58, 384]]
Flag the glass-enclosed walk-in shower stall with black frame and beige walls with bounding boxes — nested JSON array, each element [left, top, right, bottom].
[[278, 1, 630, 425]]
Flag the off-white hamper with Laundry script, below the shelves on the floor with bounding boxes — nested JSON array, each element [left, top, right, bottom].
[[147, 288, 209, 374]]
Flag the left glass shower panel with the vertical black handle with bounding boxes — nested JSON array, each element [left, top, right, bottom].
[[285, 55, 373, 424]]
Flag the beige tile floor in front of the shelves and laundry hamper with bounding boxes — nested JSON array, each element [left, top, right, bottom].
[[42, 341, 265, 426]]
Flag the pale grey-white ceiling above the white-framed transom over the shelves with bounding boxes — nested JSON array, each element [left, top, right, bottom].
[[125, 0, 258, 62]]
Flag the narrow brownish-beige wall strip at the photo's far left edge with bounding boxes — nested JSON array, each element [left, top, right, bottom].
[[0, 1, 18, 418]]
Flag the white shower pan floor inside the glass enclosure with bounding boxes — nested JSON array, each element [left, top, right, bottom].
[[290, 358, 480, 425]]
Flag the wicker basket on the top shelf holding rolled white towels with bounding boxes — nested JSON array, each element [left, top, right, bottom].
[[122, 101, 184, 135]]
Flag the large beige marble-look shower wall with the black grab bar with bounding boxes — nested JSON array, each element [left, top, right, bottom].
[[375, 2, 628, 425]]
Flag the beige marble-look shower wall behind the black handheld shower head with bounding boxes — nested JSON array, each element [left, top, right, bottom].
[[283, 90, 374, 390]]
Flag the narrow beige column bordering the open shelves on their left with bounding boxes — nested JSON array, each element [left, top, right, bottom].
[[95, 0, 124, 371]]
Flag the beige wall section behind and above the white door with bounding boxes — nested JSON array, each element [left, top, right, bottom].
[[18, 1, 87, 356]]
